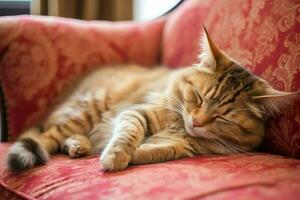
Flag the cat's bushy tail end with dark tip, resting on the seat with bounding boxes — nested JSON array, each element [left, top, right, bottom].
[[7, 128, 49, 172]]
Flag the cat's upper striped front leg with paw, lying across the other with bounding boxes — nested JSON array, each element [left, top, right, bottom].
[[100, 109, 147, 171]]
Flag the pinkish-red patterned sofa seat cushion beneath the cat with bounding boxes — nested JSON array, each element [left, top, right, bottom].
[[0, 143, 300, 200]]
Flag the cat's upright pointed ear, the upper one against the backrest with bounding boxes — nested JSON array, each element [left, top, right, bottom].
[[198, 26, 229, 70]]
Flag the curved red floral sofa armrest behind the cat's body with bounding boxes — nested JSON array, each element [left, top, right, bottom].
[[0, 16, 164, 137]]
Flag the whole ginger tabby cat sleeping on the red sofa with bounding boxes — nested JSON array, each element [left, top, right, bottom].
[[7, 27, 299, 171]]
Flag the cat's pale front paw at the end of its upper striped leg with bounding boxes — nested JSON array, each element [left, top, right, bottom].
[[100, 148, 131, 171]]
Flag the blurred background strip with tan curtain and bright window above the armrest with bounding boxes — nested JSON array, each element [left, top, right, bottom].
[[0, 0, 183, 21]]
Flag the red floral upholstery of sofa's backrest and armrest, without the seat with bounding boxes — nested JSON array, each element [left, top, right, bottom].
[[0, 0, 300, 158]]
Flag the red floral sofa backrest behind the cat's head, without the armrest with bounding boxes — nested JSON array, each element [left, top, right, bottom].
[[163, 0, 300, 158]]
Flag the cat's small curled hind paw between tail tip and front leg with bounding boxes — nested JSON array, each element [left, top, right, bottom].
[[63, 135, 91, 158]]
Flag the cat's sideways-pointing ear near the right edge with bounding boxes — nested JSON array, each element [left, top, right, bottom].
[[252, 87, 300, 116]]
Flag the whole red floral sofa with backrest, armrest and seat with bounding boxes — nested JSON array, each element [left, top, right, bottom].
[[0, 0, 300, 200]]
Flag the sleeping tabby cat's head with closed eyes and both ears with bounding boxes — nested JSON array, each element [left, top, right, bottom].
[[175, 26, 299, 150]]
